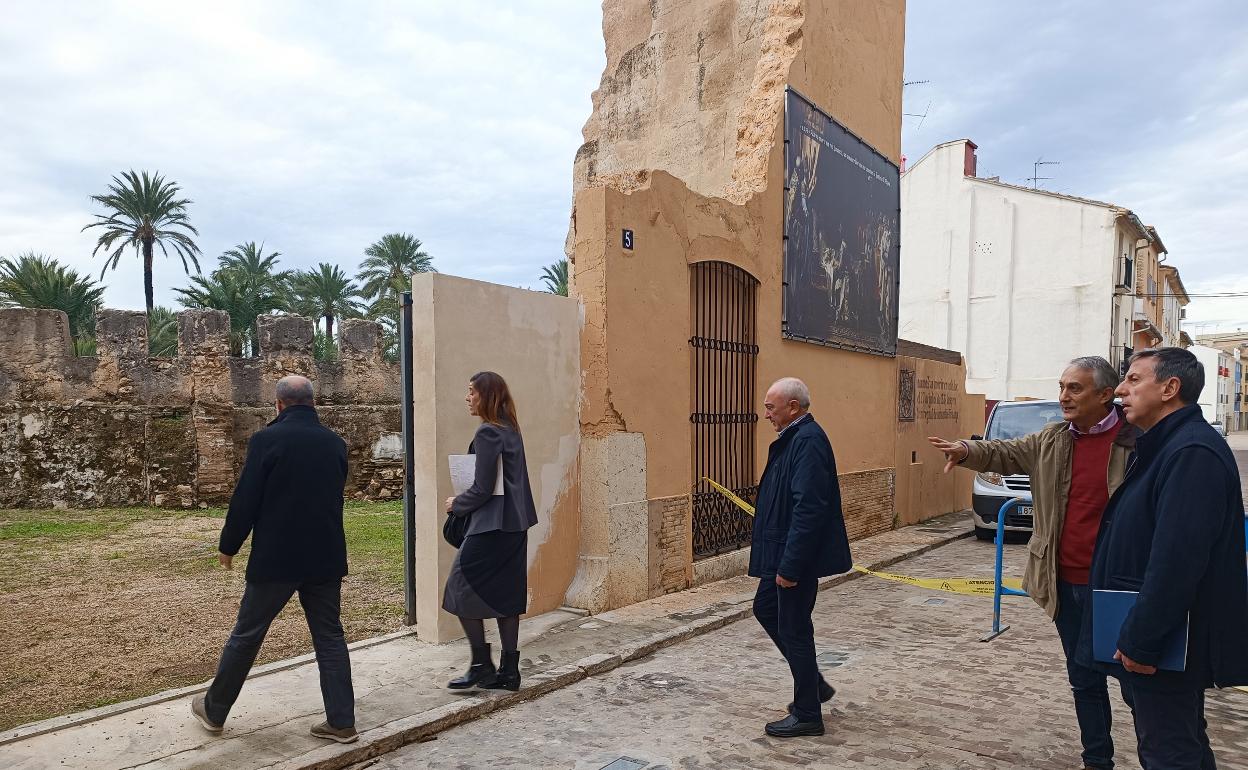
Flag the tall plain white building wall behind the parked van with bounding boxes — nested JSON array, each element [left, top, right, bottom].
[[899, 140, 1149, 401]]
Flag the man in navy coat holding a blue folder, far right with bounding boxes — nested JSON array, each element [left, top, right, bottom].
[[1078, 348, 1248, 770]]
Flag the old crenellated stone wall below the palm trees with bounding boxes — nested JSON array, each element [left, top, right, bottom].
[[0, 309, 403, 508]]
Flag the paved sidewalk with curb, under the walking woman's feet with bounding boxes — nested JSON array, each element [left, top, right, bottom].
[[0, 514, 970, 770]]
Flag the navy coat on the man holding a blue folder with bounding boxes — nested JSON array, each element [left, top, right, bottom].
[[1077, 404, 1248, 690]]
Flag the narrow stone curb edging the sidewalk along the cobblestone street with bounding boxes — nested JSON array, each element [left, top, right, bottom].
[[265, 521, 972, 770]]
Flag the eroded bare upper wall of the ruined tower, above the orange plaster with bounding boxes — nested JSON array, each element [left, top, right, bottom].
[[573, 0, 805, 203]]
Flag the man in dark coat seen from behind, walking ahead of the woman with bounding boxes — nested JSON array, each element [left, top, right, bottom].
[[191, 376, 358, 743]]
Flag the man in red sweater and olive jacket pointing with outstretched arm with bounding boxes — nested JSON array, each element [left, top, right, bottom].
[[930, 356, 1138, 768]]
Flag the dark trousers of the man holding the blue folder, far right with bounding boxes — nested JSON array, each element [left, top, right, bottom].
[[1122, 679, 1217, 770]]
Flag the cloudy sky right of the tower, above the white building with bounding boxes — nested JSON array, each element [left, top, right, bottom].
[[902, 0, 1248, 332]]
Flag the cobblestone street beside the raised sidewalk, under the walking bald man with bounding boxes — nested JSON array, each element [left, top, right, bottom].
[[367, 540, 1248, 770]]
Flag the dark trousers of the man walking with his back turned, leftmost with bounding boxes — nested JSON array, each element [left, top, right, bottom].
[[203, 578, 356, 729]]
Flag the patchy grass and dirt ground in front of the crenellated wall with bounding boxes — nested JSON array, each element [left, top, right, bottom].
[[0, 502, 403, 730]]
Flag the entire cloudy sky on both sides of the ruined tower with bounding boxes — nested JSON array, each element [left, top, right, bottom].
[[0, 0, 1248, 331]]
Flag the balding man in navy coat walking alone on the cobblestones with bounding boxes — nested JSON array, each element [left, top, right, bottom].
[[749, 377, 852, 738]]
